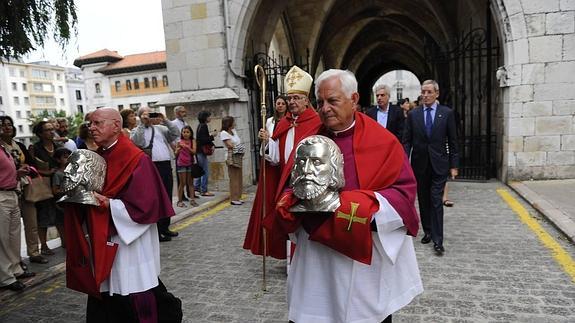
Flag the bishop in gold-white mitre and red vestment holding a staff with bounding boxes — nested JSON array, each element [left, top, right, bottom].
[[244, 65, 321, 259]]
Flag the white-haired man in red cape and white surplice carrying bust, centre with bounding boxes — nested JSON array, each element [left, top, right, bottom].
[[275, 70, 423, 323]]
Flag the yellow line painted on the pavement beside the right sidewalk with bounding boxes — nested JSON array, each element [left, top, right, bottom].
[[497, 189, 575, 282]]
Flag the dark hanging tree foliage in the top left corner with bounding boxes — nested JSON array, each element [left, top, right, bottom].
[[0, 0, 78, 59]]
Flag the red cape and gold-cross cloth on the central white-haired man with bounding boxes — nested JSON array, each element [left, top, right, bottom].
[[276, 112, 418, 264]]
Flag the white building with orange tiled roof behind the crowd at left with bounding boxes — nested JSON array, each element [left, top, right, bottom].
[[74, 49, 170, 112]]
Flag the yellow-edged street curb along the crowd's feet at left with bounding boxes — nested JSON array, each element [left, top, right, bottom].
[[0, 193, 230, 306]]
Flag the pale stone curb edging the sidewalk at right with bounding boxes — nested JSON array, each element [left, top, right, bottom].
[[507, 182, 575, 242]]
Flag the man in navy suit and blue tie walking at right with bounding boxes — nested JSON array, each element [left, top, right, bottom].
[[402, 80, 459, 255]]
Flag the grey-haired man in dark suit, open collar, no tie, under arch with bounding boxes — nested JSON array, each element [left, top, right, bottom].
[[367, 84, 405, 141]]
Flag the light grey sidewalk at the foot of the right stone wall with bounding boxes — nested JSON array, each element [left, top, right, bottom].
[[509, 179, 575, 242]]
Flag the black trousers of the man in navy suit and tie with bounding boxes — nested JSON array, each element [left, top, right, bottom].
[[415, 164, 447, 246]]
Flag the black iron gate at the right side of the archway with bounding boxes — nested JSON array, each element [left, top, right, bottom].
[[425, 9, 499, 180]]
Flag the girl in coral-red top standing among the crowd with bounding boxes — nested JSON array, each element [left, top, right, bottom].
[[176, 126, 198, 207]]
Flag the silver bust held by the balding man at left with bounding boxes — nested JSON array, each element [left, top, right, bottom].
[[58, 149, 106, 206]]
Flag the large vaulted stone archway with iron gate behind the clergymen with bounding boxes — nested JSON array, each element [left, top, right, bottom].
[[236, 0, 503, 179]]
